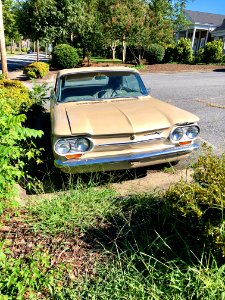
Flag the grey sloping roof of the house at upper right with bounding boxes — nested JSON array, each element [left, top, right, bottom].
[[184, 10, 225, 26]]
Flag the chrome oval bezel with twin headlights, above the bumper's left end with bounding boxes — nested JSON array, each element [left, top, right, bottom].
[[54, 136, 93, 156]]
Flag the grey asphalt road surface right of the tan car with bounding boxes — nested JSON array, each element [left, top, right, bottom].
[[142, 72, 225, 152]]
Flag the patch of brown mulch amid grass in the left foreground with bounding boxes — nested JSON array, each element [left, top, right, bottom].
[[0, 211, 106, 277]]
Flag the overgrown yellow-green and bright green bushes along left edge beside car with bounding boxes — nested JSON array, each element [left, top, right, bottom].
[[0, 80, 42, 207]]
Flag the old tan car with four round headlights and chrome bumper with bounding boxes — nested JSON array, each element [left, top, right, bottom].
[[51, 67, 199, 173]]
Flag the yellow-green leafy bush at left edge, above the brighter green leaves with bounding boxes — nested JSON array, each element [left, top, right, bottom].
[[0, 79, 33, 114]]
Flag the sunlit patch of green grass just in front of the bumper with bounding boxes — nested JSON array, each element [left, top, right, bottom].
[[29, 185, 116, 235]]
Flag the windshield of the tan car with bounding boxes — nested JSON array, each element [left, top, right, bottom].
[[57, 71, 148, 102]]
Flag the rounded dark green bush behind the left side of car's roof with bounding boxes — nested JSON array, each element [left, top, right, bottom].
[[52, 44, 79, 69]]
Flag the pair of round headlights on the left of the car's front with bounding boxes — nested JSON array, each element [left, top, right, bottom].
[[55, 137, 92, 155]]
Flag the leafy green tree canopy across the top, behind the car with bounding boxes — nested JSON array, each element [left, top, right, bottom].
[[14, 0, 187, 63]]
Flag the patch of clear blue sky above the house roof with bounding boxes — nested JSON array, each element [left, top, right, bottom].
[[186, 0, 225, 15]]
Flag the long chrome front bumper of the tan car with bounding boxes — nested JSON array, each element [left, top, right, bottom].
[[54, 143, 199, 169]]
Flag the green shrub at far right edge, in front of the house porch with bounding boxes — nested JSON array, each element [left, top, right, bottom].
[[203, 40, 223, 63]]
